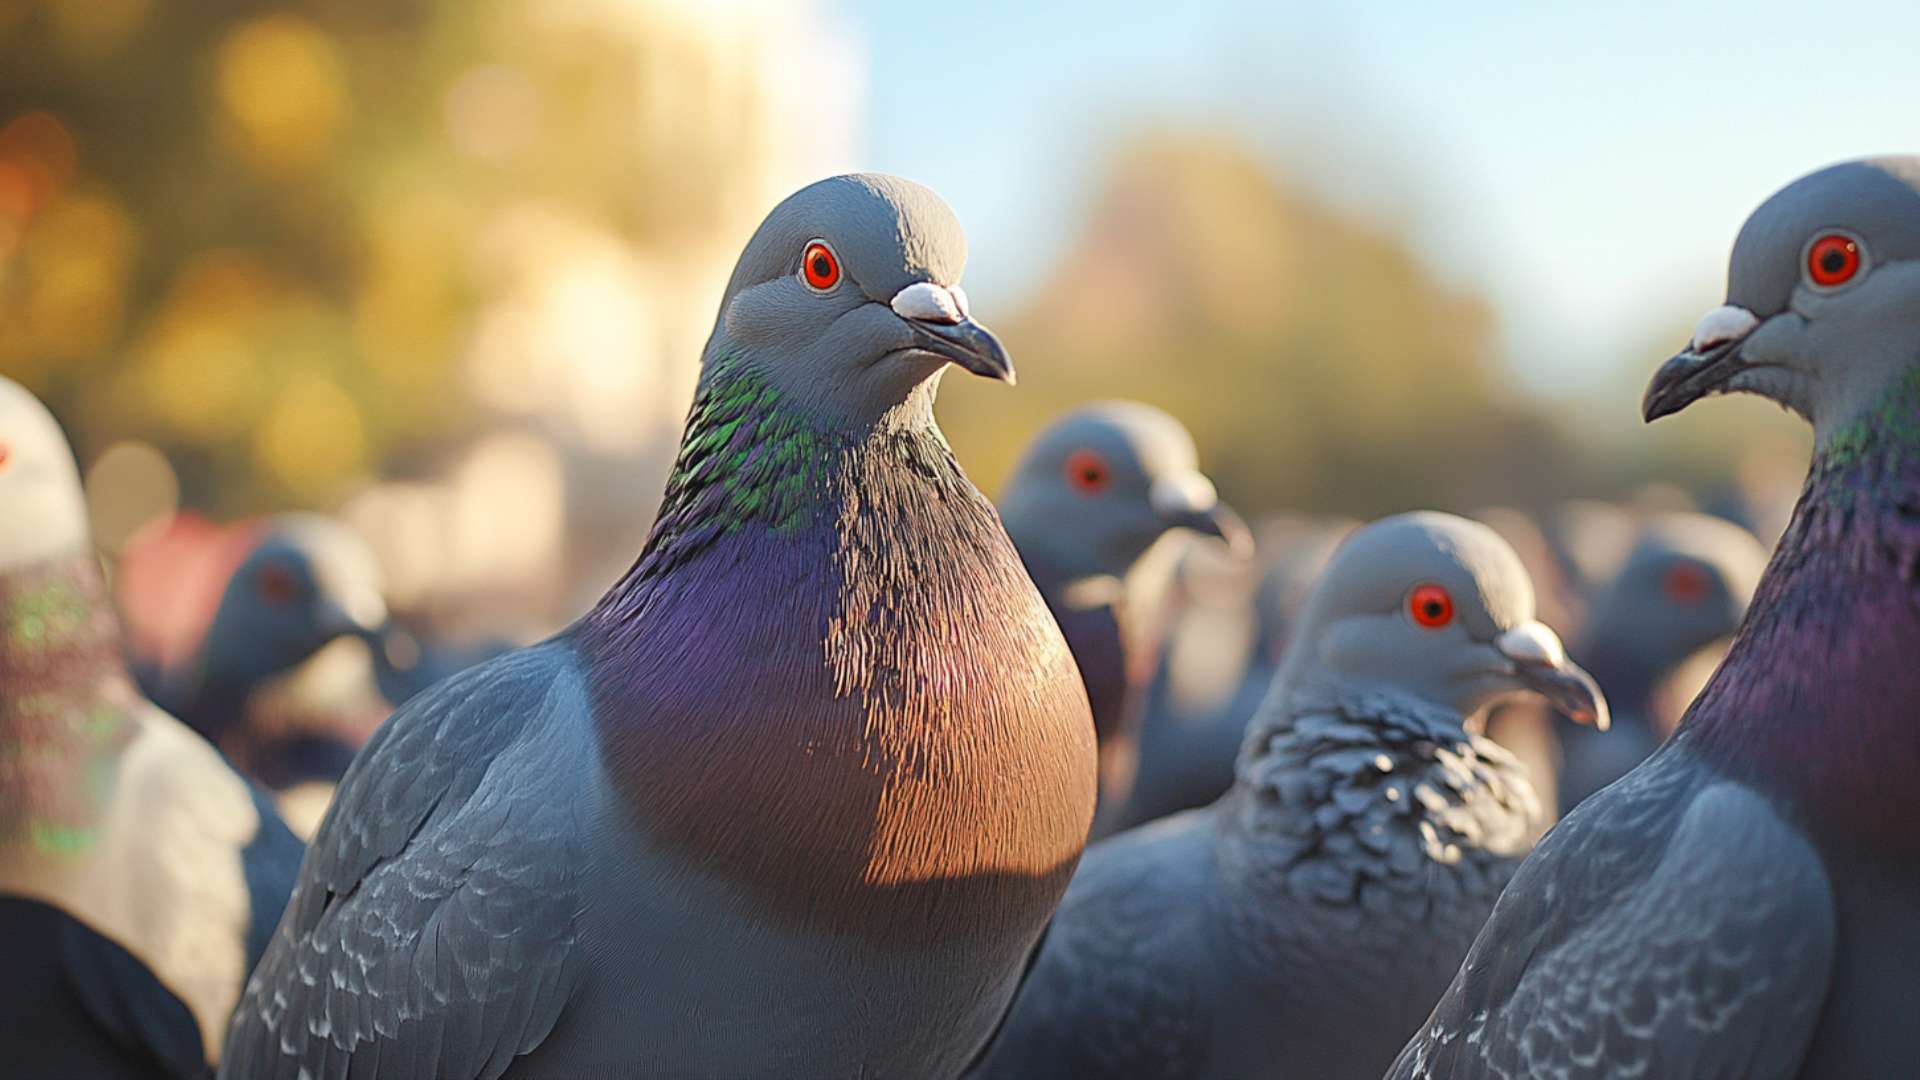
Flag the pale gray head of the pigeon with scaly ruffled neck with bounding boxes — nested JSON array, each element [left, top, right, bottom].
[[1279, 511, 1607, 728]]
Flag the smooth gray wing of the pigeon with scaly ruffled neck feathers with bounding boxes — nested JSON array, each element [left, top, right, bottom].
[[972, 811, 1213, 1080]]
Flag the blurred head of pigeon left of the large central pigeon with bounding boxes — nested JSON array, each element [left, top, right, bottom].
[[204, 513, 386, 682]]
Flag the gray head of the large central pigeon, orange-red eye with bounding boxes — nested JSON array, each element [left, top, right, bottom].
[[703, 173, 1014, 423]]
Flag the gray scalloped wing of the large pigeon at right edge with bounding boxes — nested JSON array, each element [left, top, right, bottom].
[[1388, 746, 1836, 1080]]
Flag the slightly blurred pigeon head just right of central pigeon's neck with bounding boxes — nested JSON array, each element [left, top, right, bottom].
[[1000, 402, 1252, 577]]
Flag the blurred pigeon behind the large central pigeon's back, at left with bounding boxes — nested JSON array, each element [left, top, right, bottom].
[[142, 513, 386, 792]]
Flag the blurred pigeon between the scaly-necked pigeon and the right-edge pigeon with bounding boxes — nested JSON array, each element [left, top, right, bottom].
[[1555, 511, 1766, 815]]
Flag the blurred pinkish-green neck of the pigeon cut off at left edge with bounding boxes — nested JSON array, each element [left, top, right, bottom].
[[0, 555, 136, 853]]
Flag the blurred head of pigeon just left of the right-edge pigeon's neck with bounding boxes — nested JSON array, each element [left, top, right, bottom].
[[1586, 511, 1766, 673]]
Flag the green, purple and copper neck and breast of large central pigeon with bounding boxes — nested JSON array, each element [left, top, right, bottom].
[[574, 365, 1092, 936]]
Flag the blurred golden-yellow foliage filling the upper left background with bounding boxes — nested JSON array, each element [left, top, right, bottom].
[[0, 0, 817, 513]]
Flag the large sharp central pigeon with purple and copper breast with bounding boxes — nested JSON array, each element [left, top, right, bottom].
[[223, 175, 1094, 1080]]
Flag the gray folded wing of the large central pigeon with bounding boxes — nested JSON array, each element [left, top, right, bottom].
[[221, 644, 586, 1080]]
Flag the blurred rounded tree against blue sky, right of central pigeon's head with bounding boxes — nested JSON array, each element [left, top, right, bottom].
[[947, 133, 1574, 515]]
